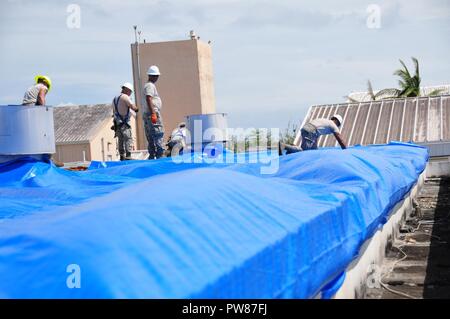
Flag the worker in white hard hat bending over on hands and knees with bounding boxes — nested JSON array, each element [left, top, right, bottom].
[[278, 114, 347, 155]]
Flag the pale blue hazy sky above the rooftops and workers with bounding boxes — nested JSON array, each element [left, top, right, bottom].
[[0, 0, 450, 129]]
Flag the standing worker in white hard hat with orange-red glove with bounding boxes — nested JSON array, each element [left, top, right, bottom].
[[142, 65, 164, 159]]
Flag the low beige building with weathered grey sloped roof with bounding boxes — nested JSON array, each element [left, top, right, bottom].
[[53, 104, 136, 163]]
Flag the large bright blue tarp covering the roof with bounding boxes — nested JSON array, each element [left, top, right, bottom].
[[0, 143, 428, 298]]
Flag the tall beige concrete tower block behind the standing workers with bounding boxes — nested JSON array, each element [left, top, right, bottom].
[[131, 39, 216, 149]]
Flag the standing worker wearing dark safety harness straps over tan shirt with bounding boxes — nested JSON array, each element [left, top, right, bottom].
[[112, 82, 138, 161]]
